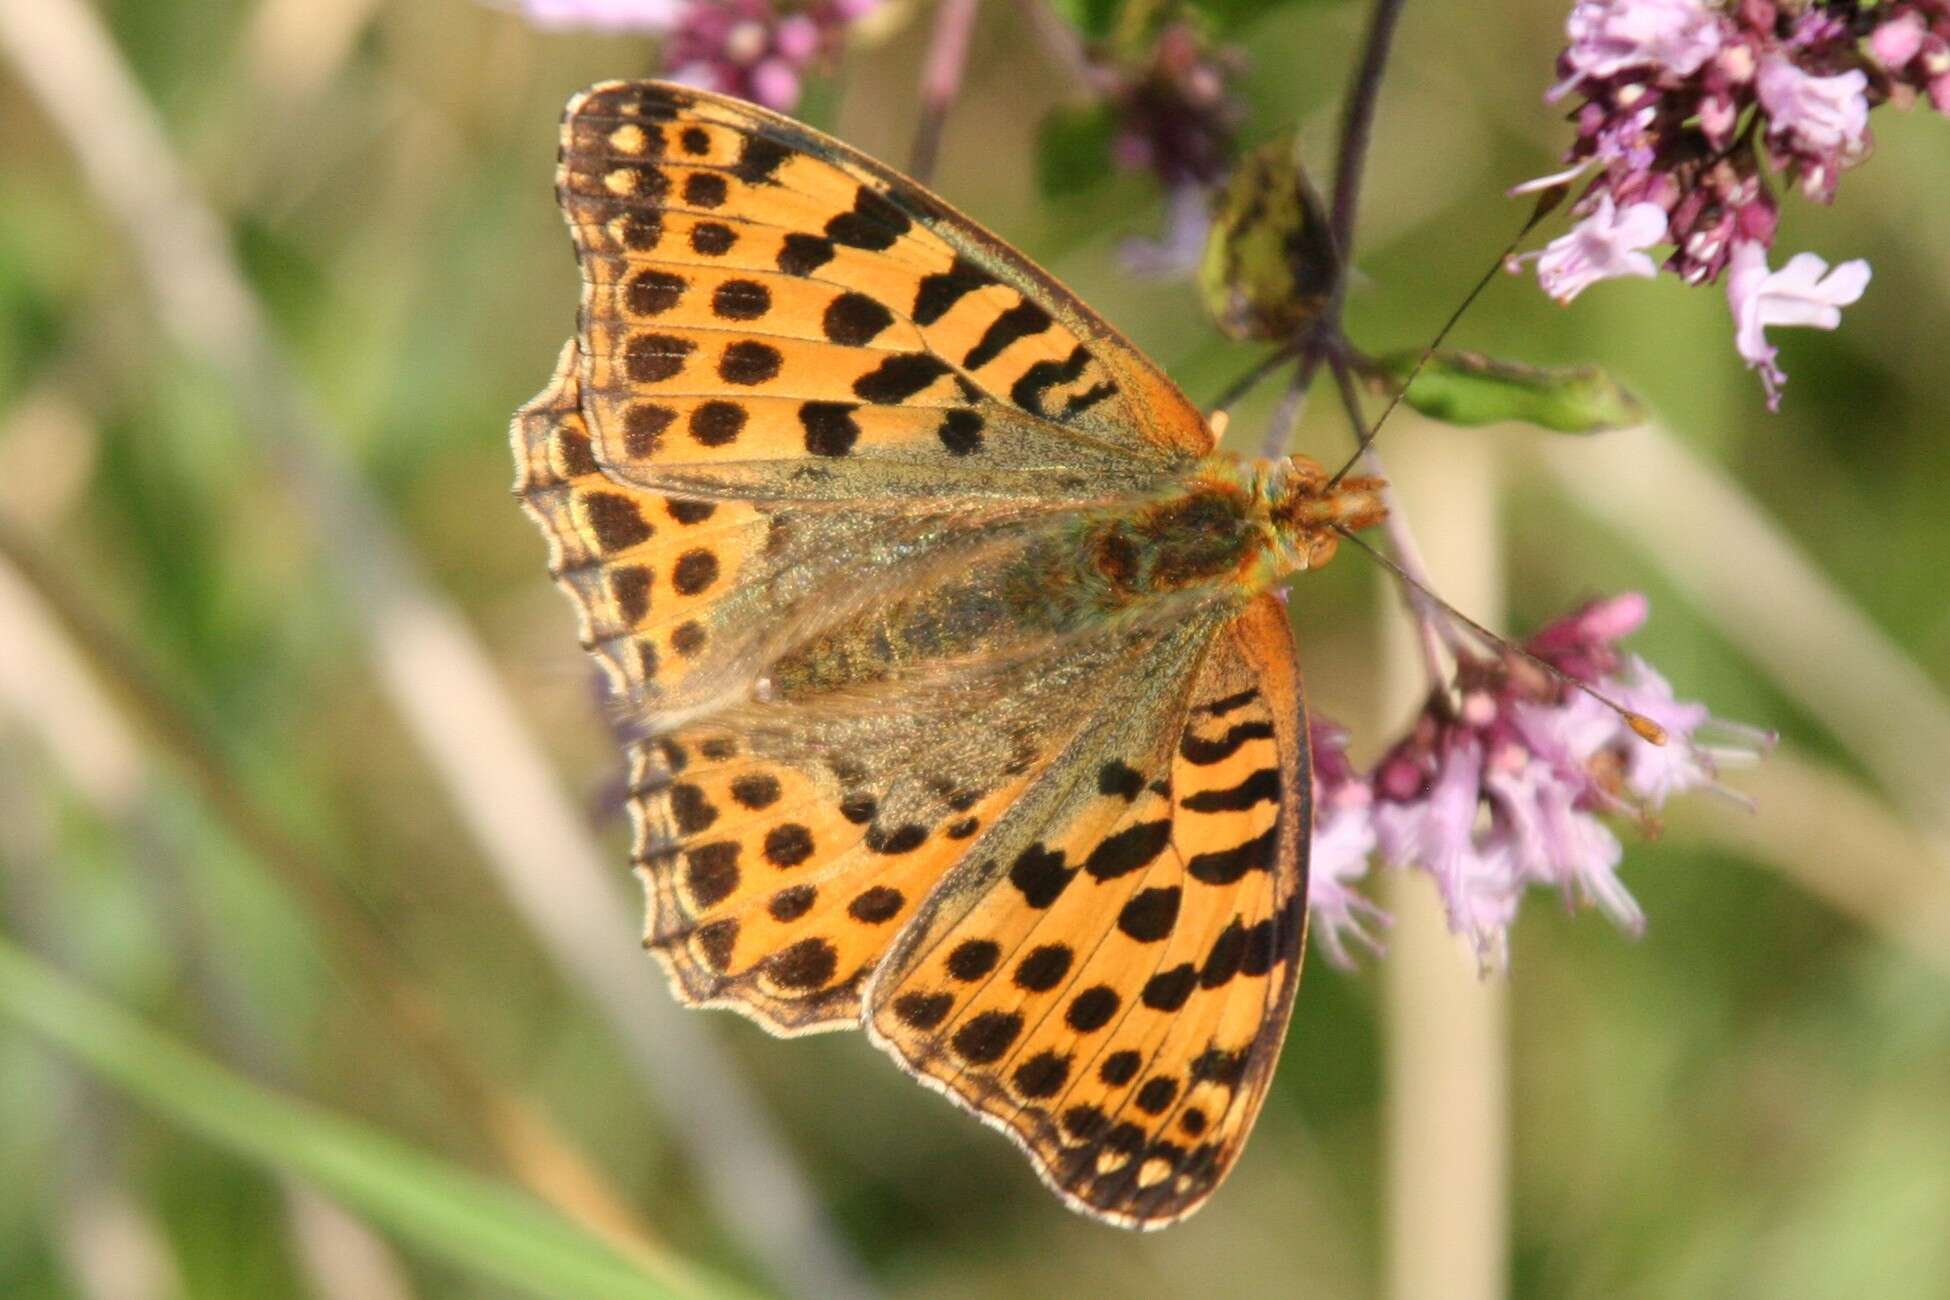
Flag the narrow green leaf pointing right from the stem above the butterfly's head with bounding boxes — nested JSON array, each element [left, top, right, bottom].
[[1381, 351, 1646, 433]]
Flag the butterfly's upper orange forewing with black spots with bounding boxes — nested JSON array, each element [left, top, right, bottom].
[[558, 84, 1211, 499]]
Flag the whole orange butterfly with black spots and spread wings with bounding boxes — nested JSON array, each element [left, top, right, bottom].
[[513, 82, 1381, 1228]]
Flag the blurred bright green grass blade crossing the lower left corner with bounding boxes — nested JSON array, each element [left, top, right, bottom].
[[0, 937, 739, 1300]]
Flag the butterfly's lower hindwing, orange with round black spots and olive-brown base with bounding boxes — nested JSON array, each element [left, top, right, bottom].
[[634, 611, 1199, 1033]]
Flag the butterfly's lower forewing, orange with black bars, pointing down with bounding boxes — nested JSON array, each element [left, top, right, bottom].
[[868, 596, 1310, 1226]]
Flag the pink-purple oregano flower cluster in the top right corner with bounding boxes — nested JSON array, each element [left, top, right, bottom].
[[1517, 0, 1950, 409]]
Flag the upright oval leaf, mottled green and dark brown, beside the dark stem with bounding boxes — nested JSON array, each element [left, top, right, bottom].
[[1199, 138, 1338, 339]]
